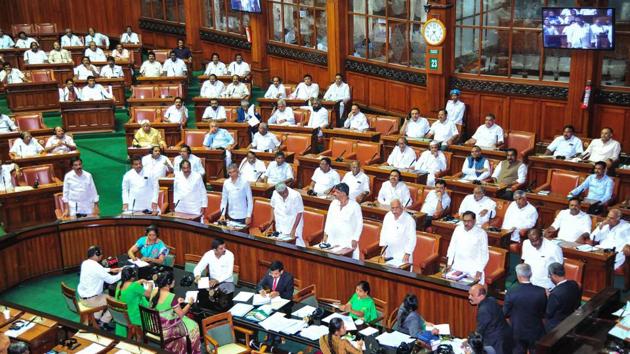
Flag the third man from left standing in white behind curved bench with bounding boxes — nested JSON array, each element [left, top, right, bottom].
[[173, 160, 208, 215]]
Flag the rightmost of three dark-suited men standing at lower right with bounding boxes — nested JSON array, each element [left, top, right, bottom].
[[545, 262, 582, 332]]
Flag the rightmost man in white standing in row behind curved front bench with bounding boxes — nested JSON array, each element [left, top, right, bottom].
[[444, 211, 489, 284]]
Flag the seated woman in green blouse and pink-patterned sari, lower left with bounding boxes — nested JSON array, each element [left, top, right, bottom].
[[152, 271, 201, 354]]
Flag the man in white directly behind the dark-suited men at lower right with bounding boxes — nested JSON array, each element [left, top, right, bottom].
[[521, 229, 564, 290]]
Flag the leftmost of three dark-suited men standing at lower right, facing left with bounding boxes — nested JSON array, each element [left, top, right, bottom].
[[468, 284, 512, 354]]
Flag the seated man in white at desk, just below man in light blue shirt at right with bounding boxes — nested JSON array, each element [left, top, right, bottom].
[[544, 197, 592, 243]]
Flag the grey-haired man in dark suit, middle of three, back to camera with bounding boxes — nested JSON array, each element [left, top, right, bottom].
[[503, 263, 547, 354]]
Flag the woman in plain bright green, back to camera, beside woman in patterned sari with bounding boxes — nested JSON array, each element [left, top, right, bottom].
[[114, 267, 153, 337]]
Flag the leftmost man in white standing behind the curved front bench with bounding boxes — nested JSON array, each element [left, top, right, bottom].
[[62, 157, 99, 217]]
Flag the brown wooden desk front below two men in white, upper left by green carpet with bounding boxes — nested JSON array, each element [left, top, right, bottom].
[[61, 100, 115, 132]]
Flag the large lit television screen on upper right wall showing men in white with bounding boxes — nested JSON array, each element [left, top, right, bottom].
[[542, 7, 615, 50]]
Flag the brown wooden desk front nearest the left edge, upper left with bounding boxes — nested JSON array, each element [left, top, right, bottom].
[[5, 81, 59, 112]]
